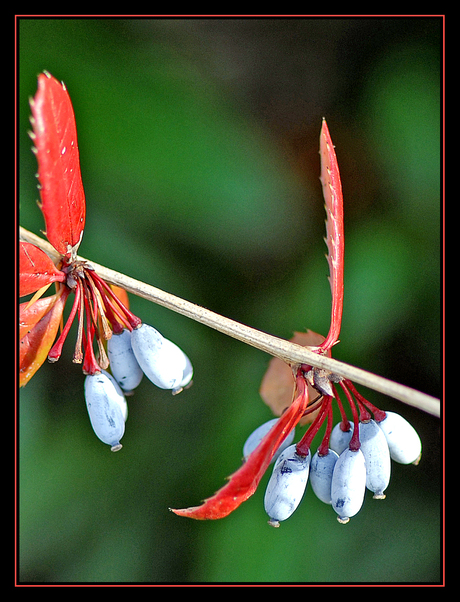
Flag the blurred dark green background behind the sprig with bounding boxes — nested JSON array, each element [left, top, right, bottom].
[[18, 18, 442, 583]]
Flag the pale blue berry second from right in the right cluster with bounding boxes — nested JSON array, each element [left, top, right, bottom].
[[359, 420, 391, 499]]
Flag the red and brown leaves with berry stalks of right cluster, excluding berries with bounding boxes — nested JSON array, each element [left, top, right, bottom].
[[172, 120, 394, 519]]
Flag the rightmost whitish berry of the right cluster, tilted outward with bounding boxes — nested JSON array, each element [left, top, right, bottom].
[[377, 412, 422, 464]]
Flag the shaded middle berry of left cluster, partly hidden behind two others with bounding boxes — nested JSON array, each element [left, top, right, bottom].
[[107, 329, 144, 391]]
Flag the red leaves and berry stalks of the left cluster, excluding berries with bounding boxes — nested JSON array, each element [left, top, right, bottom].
[[19, 72, 141, 386]]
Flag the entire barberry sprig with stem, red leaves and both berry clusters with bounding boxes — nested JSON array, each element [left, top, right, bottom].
[[19, 72, 439, 526]]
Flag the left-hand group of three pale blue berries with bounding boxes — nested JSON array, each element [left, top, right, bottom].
[[85, 324, 193, 451]]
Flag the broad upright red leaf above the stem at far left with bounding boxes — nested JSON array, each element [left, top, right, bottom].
[[30, 72, 85, 260]]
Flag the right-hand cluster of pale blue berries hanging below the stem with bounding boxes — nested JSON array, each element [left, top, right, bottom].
[[243, 408, 421, 527]]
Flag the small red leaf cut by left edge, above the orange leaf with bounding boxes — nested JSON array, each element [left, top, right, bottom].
[[19, 242, 66, 297]]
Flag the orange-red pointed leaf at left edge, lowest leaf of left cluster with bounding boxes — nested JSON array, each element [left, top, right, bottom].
[[19, 288, 70, 387]]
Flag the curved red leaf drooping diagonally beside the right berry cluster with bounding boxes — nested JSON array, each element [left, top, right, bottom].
[[171, 377, 308, 520]]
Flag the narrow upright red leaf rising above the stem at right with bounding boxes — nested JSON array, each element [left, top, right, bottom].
[[320, 119, 344, 352]]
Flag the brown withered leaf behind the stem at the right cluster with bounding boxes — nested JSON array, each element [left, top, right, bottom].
[[260, 330, 325, 424]]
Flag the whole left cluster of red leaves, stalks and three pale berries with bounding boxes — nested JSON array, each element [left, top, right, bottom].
[[19, 71, 193, 451]]
